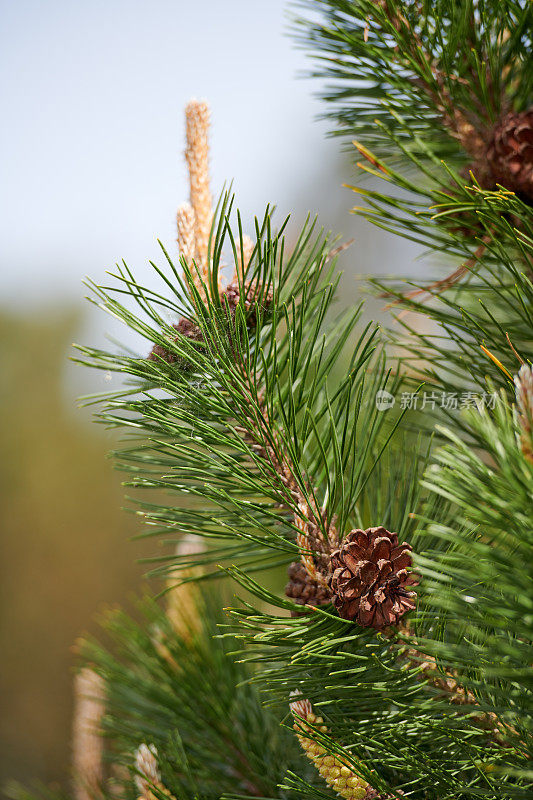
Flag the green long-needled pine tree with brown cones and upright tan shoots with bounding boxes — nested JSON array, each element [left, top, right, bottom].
[[12, 6, 533, 800]]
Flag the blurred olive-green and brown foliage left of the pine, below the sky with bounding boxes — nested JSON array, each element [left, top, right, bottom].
[[0, 310, 147, 786]]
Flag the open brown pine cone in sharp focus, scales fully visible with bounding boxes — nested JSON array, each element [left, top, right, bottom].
[[329, 527, 418, 630]]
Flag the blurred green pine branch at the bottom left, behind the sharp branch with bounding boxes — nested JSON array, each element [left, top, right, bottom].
[[79, 595, 304, 798]]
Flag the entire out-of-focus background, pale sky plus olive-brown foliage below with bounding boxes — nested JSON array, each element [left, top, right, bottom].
[[0, 0, 420, 786]]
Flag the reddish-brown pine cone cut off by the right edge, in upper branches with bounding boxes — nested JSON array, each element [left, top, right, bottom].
[[487, 107, 533, 201]]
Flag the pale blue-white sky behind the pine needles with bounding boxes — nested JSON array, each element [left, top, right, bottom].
[[0, 0, 424, 354]]
